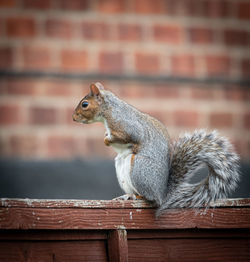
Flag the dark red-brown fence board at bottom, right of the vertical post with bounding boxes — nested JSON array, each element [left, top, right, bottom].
[[128, 238, 250, 262]]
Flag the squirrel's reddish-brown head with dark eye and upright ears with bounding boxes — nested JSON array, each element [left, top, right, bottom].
[[72, 83, 104, 124]]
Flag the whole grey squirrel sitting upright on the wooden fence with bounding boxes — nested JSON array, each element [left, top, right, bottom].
[[73, 83, 239, 216]]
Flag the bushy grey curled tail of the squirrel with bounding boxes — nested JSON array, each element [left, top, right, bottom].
[[157, 130, 239, 215]]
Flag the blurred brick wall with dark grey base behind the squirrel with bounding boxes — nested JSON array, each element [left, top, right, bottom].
[[0, 0, 250, 199]]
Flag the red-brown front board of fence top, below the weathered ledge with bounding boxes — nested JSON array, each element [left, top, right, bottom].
[[0, 207, 250, 230]]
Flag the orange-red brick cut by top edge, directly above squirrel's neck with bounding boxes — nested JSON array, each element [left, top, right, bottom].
[[97, 0, 126, 14]]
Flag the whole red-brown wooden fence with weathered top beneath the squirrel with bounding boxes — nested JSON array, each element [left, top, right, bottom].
[[0, 199, 250, 262]]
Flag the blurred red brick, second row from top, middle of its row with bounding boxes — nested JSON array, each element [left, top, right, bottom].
[[118, 24, 142, 41]]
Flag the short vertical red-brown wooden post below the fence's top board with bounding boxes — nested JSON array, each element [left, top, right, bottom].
[[108, 229, 128, 262]]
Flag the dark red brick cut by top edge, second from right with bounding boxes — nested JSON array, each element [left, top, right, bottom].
[[200, 0, 231, 18]]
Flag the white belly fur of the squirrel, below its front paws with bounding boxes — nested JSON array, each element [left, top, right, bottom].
[[112, 144, 138, 194]]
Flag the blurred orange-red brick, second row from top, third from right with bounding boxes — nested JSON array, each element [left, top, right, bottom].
[[153, 25, 183, 44]]
